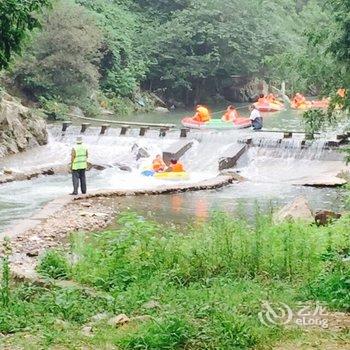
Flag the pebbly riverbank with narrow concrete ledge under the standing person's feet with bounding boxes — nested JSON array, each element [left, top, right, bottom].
[[1, 174, 236, 279]]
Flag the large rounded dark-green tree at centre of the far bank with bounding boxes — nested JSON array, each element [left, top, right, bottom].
[[144, 0, 284, 102]]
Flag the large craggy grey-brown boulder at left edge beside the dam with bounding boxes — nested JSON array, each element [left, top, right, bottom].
[[0, 95, 48, 157]]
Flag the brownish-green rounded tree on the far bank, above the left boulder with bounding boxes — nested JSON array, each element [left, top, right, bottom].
[[13, 1, 102, 104]]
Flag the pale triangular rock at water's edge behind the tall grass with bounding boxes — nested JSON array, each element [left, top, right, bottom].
[[274, 197, 314, 222]]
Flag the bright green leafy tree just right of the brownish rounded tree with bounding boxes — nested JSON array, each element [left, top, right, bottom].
[[78, 0, 148, 97]]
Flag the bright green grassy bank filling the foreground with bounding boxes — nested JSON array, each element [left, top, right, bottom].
[[0, 214, 350, 349]]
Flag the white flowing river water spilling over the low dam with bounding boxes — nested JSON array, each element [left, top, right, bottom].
[[0, 111, 343, 229]]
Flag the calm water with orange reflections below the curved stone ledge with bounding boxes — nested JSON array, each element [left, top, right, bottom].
[[106, 182, 343, 224]]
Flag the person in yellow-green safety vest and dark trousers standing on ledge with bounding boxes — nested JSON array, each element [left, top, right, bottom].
[[71, 136, 88, 196]]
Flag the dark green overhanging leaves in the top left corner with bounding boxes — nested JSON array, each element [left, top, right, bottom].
[[0, 0, 50, 69]]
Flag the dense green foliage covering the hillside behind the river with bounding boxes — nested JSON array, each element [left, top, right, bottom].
[[3, 0, 347, 110]]
